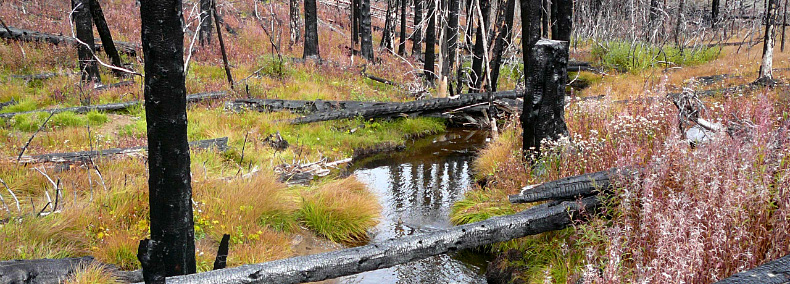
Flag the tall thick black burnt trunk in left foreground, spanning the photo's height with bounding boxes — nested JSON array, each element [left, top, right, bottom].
[[140, 0, 195, 276]]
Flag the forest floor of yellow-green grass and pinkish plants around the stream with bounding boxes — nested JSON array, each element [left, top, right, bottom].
[[0, 0, 790, 283]]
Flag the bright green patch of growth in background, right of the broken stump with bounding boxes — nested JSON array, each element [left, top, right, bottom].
[[592, 41, 721, 72]]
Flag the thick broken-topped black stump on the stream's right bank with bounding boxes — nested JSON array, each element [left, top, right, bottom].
[[522, 39, 568, 156]]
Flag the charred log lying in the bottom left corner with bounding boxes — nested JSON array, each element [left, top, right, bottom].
[[0, 256, 143, 284]]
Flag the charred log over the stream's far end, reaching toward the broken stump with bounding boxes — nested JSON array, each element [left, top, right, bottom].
[[291, 91, 523, 124]]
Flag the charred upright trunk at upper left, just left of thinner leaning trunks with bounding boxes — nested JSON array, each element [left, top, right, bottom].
[[71, 0, 101, 83]]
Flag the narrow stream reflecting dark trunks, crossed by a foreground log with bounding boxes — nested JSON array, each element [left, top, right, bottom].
[[339, 129, 496, 284]]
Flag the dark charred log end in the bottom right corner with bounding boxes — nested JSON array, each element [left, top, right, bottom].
[[716, 255, 790, 284]]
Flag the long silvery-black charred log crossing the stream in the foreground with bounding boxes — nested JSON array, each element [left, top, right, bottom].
[[142, 197, 600, 284]]
